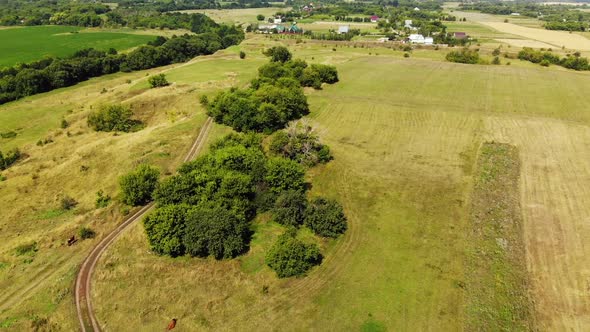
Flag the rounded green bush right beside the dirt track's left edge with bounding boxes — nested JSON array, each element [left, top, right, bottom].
[[119, 164, 160, 206]]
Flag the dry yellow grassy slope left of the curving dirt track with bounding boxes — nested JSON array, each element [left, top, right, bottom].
[[0, 46, 256, 330]]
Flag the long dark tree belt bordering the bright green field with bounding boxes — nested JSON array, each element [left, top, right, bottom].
[[0, 22, 244, 104]]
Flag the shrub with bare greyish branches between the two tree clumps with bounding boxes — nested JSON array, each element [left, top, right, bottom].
[[269, 122, 332, 167]]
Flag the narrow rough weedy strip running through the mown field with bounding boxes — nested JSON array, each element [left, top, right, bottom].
[[464, 142, 534, 331]]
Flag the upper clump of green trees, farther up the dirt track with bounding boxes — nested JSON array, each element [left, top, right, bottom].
[[206, 46, 338, 134]]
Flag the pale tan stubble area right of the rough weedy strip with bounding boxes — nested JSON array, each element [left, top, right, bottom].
[[486, 118, 590, 331]]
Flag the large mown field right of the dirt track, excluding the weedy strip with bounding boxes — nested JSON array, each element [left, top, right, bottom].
[[88, 37, 590, 331]]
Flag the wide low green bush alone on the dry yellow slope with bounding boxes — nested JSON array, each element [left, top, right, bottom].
[[88, 105, 141, 132]]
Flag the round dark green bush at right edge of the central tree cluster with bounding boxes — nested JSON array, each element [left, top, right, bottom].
[[305, 198, 348, 238]]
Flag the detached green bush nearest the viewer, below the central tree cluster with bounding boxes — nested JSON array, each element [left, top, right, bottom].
[[266, 231, 322, 278]]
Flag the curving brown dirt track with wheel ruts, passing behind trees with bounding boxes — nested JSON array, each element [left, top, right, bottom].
[[74, 118, 213, 332]]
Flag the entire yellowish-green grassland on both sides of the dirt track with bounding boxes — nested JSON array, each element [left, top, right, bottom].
[[0, 29, 590, 331]]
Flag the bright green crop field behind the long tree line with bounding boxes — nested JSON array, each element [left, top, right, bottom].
[[0, 26, 154, 67]]
